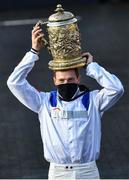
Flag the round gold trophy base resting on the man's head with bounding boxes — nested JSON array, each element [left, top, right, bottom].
[[48, 57, 86, 71]]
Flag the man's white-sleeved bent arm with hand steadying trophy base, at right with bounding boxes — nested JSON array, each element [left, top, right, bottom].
[[83, 53, 124, 111]]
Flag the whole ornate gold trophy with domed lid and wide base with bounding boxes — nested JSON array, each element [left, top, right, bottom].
[[38, 4, 85, 70]]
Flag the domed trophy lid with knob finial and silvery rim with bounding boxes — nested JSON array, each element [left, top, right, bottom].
[[47, 4, 77, 26]]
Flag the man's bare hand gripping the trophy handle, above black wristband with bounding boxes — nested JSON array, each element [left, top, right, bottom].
[[32, 24, 44, 52]]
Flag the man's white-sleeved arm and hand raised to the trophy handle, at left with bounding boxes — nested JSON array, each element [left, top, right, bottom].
[[7, 23, 43, 112]]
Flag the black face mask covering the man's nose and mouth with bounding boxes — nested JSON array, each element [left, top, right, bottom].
[[57, 83, 78, 101]]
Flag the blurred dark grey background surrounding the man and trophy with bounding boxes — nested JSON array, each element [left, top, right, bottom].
[[0, 0, 129, 179]]
